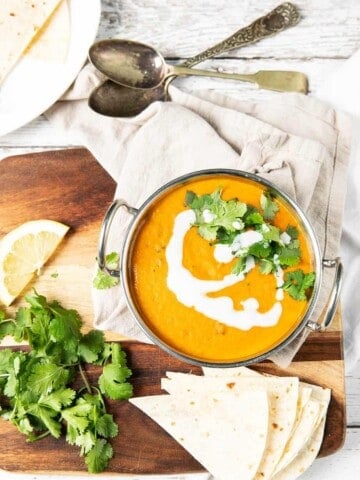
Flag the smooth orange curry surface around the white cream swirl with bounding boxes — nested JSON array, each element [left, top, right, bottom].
[[128, 175, 313, 362]]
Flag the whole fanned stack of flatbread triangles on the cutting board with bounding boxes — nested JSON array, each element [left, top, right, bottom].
[[130, 367, 330, 480]]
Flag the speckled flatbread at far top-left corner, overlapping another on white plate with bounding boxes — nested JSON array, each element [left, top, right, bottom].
[[0, 0, 64, 83]]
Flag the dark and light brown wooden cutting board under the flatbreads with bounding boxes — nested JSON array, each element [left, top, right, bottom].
[[0, 149, 346, 474]]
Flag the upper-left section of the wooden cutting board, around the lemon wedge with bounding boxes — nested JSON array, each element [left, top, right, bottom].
[[0, 149, 115, 326]]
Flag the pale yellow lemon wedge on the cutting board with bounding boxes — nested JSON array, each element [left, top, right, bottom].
[[0, 220, 69, 306]]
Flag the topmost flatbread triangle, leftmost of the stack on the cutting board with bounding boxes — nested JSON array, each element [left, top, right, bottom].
[[130, 389, 268, 480]]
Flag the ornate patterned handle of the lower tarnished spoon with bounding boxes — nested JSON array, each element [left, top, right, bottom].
[[180, 2, 300, 67]]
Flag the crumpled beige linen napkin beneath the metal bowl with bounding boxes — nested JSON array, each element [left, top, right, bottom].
[[47, 66, 351, 366]]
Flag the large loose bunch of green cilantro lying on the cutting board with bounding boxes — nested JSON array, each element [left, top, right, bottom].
[[0, 292, 132, 473]]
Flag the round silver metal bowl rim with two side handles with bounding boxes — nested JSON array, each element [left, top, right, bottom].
[[98, 169, 342, 367]]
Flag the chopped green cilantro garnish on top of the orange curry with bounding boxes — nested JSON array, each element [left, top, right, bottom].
[[185, 188, 315, 300]]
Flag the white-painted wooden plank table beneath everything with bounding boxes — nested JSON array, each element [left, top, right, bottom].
[[0, 0, 360, 480]]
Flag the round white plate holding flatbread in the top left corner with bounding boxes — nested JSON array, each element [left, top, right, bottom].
[[0, 0, 101, 136]]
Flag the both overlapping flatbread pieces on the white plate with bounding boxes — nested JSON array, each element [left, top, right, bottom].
[[0, 0, 70, 83]]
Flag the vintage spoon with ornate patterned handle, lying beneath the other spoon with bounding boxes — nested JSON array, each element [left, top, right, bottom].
[[89, 3, 300, 117]]
